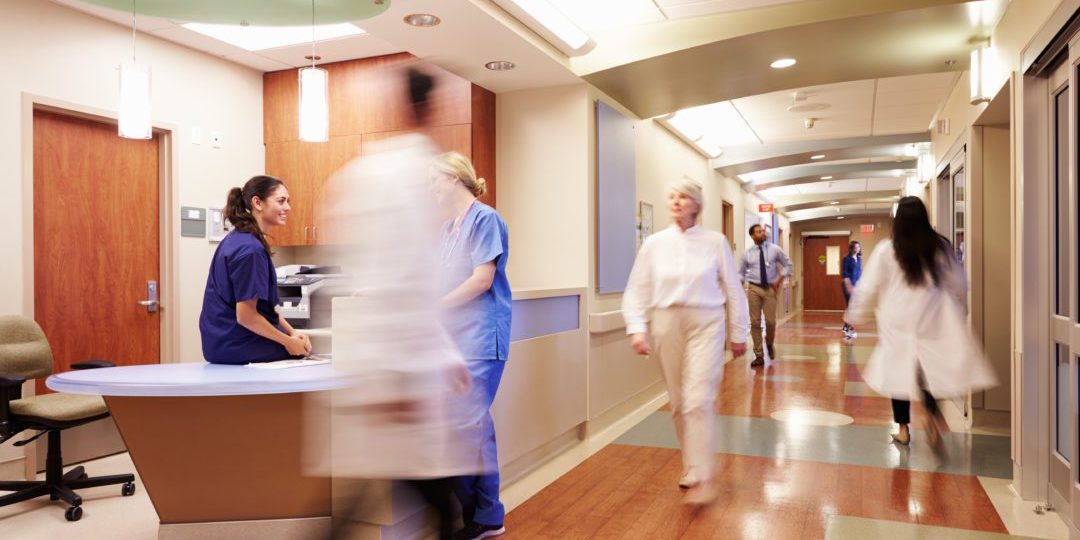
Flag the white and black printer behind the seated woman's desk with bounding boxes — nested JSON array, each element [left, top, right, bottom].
[[278, 265, 345, 328]]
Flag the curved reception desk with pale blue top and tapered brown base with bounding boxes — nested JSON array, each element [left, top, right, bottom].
[[46, 362, 345, 539]]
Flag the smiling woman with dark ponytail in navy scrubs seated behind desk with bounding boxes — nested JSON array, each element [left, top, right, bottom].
[[199, 176, 311, 364]]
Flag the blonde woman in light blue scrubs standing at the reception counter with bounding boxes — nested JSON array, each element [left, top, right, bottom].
[[432, 152, 511, 540]]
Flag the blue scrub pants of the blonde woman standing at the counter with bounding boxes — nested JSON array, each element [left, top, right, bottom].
[[454, 360, 507, 525]]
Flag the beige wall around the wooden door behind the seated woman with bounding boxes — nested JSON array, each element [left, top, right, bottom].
[[0, 0, 262, 477]]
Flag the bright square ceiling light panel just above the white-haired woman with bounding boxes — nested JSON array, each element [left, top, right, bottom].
[[666, 102, 760, 152]]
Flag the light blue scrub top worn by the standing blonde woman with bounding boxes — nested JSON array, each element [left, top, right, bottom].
[[440, 201, 512, 361]]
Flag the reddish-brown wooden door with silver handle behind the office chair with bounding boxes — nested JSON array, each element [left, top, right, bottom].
[[33, 111, 161, 393]]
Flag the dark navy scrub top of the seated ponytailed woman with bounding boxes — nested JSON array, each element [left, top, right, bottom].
[[199, 231, 294, 364]]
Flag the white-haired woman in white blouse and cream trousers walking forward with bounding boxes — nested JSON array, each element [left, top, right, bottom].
[[622, 178, 750, 504]]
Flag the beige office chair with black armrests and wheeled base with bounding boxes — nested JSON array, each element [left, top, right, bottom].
[[0, 315, 135, 522]]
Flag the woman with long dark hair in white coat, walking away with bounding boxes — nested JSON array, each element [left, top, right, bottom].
[[843, 197, 997, 448]]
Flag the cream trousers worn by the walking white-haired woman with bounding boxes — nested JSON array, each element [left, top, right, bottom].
[[652, 307, 726, 482]]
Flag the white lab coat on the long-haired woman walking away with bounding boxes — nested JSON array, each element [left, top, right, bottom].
[[843, 241, 997, 401]]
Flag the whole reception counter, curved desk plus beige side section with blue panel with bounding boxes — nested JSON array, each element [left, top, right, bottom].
[[46, 288, 588, 540]]
